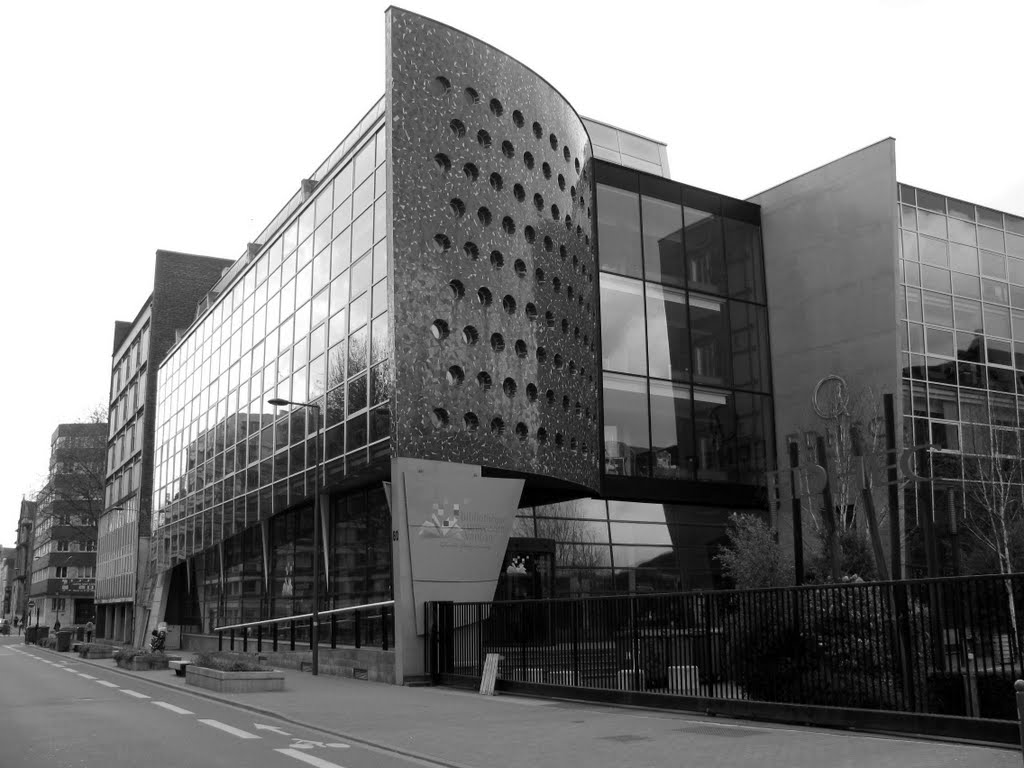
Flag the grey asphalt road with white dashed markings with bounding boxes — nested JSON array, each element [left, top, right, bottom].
[[0, 636, 425, 768]]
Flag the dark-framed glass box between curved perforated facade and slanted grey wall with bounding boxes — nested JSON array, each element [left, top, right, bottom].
[[597, 164, 773, 483]]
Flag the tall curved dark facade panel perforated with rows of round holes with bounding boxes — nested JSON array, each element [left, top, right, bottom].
[[387, 8, 600, 488]]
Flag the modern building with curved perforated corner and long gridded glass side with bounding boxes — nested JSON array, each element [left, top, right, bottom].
[[146, 8, 774, 679]]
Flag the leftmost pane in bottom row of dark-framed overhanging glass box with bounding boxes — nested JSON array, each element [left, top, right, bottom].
[[604, 374, 650, 477]]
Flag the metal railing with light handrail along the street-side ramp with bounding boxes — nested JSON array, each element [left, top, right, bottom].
[[213, 600, 394, 653]]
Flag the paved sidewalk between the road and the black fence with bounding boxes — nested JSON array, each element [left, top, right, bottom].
[[28, 646, 1021, 768]]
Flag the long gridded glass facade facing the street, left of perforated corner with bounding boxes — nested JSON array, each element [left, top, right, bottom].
[[153, 124, 390, 573]]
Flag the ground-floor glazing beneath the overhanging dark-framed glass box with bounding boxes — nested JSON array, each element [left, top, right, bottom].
[[505, 499, 734, 597]]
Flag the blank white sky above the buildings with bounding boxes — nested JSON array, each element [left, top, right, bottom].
[[0, 0, 1024, 545]]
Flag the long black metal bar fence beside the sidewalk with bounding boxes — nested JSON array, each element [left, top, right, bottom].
[[427, 573, 1024, 720]]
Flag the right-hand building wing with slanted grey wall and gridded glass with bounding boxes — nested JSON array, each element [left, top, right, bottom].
[[752, 139, 1024, 577]]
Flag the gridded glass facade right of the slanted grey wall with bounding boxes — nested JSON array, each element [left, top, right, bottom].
[[897, 184, 1024, 552]]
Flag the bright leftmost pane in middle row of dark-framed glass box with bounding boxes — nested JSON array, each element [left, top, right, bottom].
[[601, 274, 647, 374]]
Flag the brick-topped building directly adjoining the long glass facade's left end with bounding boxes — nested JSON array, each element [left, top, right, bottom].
[[96, 251, 232, 642]]
